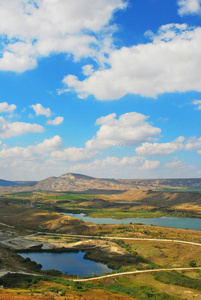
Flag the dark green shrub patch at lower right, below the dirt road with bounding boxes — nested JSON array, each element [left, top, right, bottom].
[[154, 271, 201, 290]]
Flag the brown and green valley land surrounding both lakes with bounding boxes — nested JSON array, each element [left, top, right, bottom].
[[0, 174, 201, 300]]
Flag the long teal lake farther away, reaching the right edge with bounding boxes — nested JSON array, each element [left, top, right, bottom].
[[63, 213, 201, 230]]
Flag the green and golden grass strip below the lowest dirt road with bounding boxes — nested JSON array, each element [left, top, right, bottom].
[[0, 272, 201, 300]]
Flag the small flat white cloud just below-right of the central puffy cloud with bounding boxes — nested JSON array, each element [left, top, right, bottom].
[[135, 136, 185, 156]]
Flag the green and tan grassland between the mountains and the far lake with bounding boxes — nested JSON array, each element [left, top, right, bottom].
[[0, 190, 201, 219]]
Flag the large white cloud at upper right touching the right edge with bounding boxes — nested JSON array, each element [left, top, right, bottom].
[[63, 24, 201, 100]]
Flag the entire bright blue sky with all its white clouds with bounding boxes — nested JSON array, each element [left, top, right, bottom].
[[0, 0, 201, 180]]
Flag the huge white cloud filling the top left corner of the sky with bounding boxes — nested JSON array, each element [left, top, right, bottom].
[[0, 0, 126, 72]]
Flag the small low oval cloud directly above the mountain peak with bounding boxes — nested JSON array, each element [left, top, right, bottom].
[[51, 147, 98, 161]]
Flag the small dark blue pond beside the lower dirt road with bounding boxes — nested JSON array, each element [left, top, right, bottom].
[[18, 251, 113, 277]]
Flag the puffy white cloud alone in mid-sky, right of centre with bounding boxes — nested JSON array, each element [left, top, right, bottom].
[[85, 112, 161, 149]]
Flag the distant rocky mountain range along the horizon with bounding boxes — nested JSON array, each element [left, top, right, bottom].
[[0, 173, 201, 193]]
